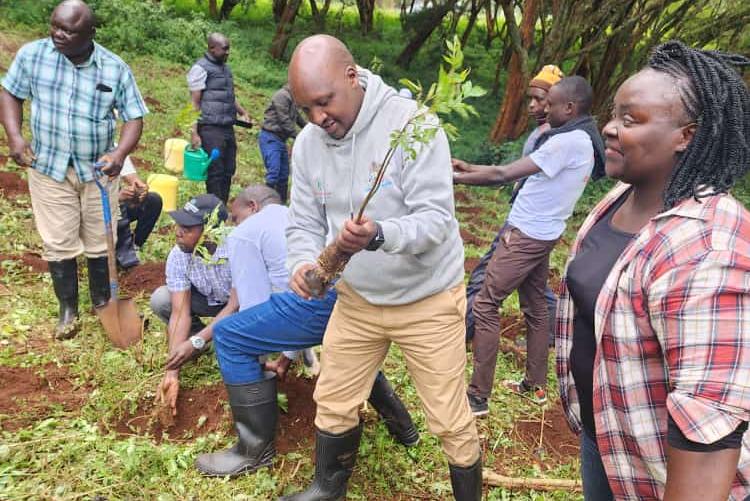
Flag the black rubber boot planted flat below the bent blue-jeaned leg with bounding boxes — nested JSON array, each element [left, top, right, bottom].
[[195, 372, 279, 477]]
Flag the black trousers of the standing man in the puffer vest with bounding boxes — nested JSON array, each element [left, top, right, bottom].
[[198, 124, 237, 204]]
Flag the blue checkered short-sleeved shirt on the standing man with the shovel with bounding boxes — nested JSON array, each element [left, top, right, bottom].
[[2, 38, 148, 182]]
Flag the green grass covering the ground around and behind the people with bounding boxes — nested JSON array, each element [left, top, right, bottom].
[[0, 0, 601, 500]]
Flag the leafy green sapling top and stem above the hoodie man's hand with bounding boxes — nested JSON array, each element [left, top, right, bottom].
[[356, 36, 487, 222]]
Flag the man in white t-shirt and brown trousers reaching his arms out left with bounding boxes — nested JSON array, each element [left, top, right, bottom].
[[453, 76, 603, 416]]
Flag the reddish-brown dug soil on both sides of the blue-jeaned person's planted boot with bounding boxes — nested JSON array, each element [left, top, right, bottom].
[[112, 374, 315, 454]]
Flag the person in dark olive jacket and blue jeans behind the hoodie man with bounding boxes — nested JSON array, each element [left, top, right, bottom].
[[258, 84, 307, 203]]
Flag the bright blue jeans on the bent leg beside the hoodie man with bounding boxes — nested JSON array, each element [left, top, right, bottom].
[[213, 289, 336, 384]]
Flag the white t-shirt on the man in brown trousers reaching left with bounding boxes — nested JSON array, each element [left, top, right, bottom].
[[508, 130, 594, 240]]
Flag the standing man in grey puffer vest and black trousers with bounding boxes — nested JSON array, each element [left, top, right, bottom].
[[187, 33, 250, 204]]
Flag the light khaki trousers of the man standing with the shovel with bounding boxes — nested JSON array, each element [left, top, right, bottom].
[[27, 167, 119, 261]]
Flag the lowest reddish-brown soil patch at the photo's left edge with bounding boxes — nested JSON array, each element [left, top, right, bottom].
[[0, 364, 88, 431]]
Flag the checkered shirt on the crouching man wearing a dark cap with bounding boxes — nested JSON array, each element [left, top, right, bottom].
[[166, 244, 232, 306]]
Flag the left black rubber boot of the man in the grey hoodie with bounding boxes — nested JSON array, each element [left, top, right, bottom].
[[279, 423, 362, 501]]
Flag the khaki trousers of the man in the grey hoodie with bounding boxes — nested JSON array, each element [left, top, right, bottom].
[[314, 281, 480, 467]]
